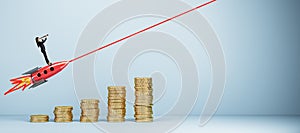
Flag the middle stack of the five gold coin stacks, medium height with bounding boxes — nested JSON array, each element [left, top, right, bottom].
[[80, 99, 100, 122]]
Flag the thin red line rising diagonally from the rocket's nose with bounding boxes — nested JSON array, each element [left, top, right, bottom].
[[69, 0, 216, 62]]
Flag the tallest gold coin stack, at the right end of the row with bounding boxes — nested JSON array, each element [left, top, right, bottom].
[[134, 78, 153, 122]]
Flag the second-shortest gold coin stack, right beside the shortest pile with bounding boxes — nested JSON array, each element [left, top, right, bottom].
[[53, 106, 73, 122]]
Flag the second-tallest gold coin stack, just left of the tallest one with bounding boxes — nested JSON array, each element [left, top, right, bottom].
[[107, 86, 126, 122]]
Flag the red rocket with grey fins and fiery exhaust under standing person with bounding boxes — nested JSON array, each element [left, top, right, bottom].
[[4, 61, 69, 95]]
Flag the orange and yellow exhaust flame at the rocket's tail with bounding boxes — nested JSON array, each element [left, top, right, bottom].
[[4, 75, 32, 95]]
